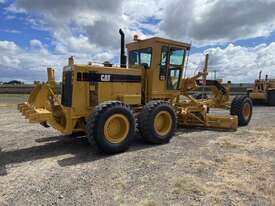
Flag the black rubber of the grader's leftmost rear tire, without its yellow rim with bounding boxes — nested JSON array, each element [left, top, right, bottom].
[[86, 101, 136, 154]]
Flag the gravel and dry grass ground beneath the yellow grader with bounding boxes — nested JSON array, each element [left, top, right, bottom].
[[0, 97, 275, 206]]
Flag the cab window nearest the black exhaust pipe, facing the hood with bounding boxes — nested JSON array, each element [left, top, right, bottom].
[[129, 48, 152, 67]]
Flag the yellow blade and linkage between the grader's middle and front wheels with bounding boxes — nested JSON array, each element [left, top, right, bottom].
[[175, 55, 238, 130]]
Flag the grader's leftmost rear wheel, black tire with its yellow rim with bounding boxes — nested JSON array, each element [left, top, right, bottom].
[[86, 101, 135, 154]]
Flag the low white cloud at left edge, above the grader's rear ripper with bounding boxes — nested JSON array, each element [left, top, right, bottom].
[[0, 40, 64, 81]]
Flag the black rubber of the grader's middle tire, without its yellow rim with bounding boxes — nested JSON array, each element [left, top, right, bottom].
[[137, 100, 177, 144]]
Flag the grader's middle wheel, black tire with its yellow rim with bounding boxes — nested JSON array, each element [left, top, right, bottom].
[[137, 101, 177, 144]]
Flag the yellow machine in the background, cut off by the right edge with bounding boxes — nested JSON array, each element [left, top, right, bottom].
[[247, 71, 275, 106]]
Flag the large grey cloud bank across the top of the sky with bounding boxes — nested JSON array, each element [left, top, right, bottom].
[[5, 0, 275, 45]]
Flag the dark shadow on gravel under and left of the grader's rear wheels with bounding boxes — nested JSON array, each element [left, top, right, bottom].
[[0, 136, 157, 176]]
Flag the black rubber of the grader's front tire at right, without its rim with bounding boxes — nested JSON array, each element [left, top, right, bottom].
[[230, 95, 253, 126]]
